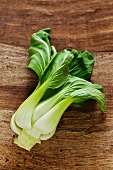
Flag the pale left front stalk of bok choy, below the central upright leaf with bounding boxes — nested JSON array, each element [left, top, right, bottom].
[[15, 81, 48, 129]]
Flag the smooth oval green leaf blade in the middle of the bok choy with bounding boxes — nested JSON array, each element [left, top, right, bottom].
[[41, 50, 73, 89]]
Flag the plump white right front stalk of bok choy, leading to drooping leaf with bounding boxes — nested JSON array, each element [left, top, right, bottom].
[[33, 97, 74, 134]]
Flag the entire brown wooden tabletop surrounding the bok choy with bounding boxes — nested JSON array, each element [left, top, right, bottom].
[[0, 0, 113, 170]]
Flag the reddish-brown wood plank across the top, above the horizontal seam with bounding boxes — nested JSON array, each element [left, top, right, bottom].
[[0, 0, 113, 51]]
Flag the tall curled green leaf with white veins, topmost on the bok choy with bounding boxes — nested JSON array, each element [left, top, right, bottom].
[[28, 28, 56, 78]]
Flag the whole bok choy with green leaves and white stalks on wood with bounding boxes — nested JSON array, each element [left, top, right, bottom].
[[11, 28, 106, 150]]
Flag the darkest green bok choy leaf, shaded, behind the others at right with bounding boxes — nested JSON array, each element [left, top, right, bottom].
[[68, 49, 94, 80]]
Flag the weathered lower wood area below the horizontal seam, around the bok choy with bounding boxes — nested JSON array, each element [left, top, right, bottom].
[[0, 44, 113, 170]]
